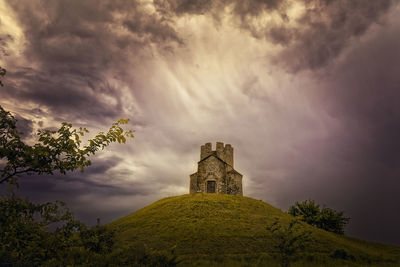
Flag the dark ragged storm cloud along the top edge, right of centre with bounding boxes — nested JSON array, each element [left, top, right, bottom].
[[155, 0, 395, 72]]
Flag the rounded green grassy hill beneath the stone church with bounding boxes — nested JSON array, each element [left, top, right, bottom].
[[109, 194, 400, 266]]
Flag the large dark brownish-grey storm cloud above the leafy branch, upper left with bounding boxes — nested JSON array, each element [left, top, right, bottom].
[[1, 1, 181, 122]]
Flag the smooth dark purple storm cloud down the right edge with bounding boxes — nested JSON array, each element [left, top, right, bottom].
[[320, 22, 400, 244]]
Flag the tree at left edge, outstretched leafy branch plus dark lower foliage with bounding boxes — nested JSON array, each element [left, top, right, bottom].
[[0, 67, 133, 266]]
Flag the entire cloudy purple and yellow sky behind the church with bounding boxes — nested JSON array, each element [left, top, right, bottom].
[[0, 0, 400, 245]]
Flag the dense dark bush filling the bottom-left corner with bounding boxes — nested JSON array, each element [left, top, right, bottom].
[[0, 189, 85, 266]]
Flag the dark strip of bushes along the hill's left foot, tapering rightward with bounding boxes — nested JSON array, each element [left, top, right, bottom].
[[0, 191, 179, 266]]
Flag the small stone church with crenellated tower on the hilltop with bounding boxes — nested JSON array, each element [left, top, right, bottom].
[[189, 142, 243, 196]]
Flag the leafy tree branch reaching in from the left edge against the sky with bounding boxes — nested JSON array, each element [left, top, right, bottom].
[[0, 106, 133, 183]]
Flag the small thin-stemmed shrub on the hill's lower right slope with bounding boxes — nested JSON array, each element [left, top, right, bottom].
[[267, 219, 311, 267]]
